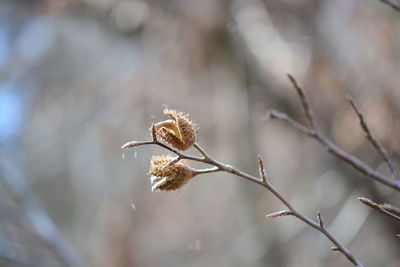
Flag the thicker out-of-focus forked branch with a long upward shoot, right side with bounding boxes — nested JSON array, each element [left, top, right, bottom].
[[269, 75, 400, 191]]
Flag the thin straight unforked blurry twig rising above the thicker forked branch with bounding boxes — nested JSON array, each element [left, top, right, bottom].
[[347, 96, 396, 177]]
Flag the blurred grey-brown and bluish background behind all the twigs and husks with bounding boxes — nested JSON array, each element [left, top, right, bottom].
[[0, 0, 400, 267]]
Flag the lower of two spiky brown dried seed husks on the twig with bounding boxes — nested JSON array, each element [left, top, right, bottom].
[[149, 155, 195, 191]]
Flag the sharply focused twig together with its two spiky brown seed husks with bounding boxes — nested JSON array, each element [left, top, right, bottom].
[[122, 108, 363, 267]]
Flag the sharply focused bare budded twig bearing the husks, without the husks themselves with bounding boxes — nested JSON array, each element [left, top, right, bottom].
[[122, 139, 363, 266]]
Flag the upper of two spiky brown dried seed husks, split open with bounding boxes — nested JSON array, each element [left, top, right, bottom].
[[154, 109, 196, 150]]
